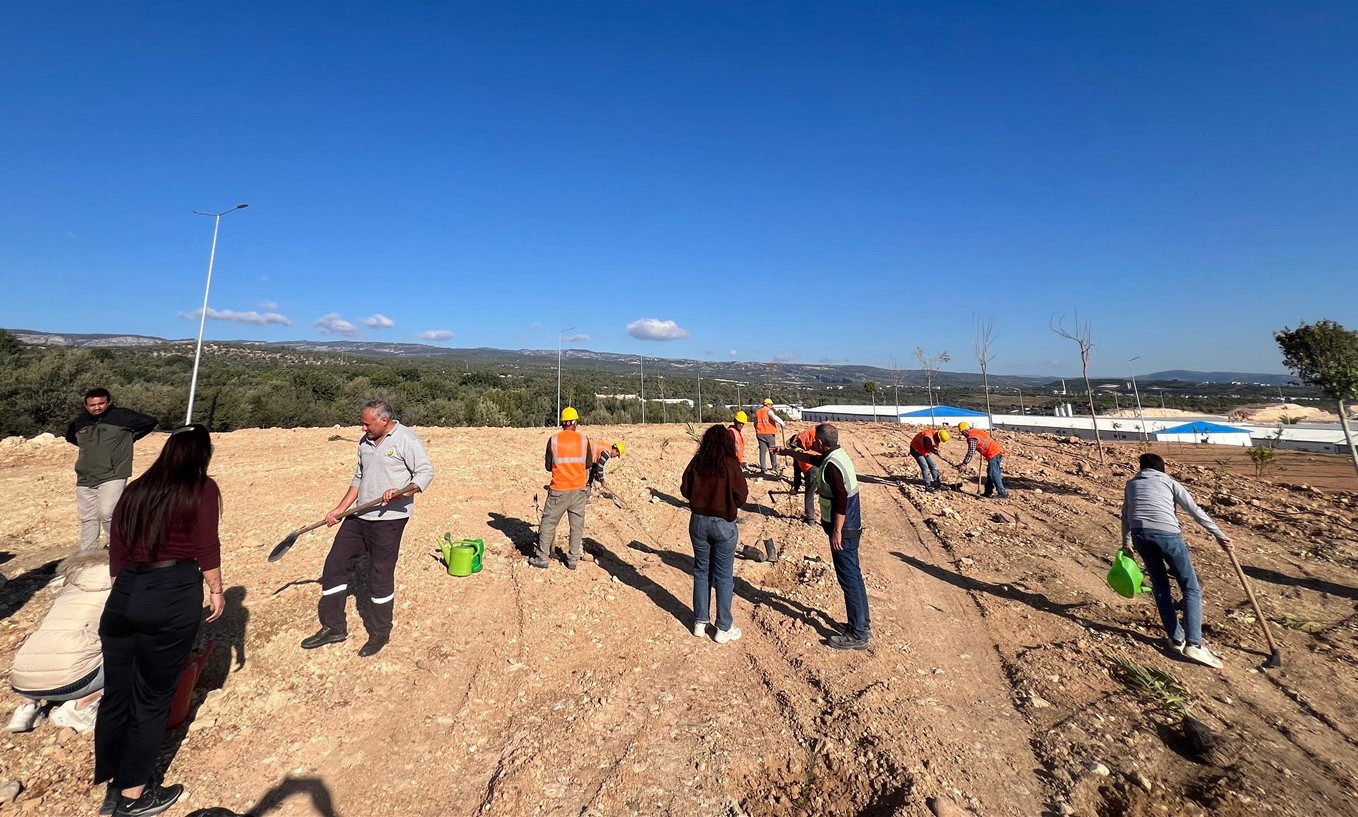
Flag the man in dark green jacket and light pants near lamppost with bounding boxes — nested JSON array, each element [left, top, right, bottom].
[[67, 388, 156, 551]]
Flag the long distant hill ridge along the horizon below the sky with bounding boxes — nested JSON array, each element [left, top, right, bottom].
[[2, 328, 1290, 392]]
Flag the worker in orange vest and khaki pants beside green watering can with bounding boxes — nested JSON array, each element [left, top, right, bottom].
[[528, 406, 595, 570]]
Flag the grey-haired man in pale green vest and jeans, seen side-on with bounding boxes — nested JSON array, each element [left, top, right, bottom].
[[779, 422, 872, 650]]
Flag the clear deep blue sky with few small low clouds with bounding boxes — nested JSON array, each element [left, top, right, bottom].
[[0, 1, 1358, 375]]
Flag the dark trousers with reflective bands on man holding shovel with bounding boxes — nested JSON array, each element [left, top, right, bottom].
[[319, 517, 410, 635]]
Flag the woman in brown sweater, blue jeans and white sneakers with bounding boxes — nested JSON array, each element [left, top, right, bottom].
[[679, 425, 750, 643]]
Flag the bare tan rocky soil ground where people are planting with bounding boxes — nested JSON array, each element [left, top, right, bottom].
[[0, 425, 1358, 817]]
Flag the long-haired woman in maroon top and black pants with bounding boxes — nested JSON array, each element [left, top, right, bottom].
[[94, 425, 225, 817]]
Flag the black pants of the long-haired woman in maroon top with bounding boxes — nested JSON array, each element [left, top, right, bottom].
[[94, 562, 202, 789]]
